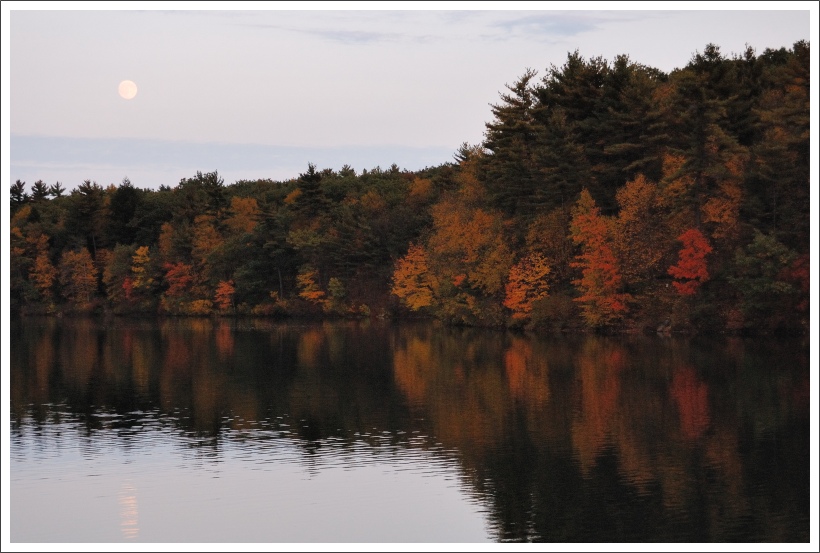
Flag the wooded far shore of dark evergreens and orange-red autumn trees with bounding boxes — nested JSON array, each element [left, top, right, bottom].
[[11, 42, 810, 332]]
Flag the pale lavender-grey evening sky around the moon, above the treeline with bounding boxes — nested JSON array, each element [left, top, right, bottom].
[[2, 2, 817, 190]]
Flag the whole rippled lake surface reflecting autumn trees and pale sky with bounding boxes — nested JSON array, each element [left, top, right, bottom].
[[10, 318, 810, 543]]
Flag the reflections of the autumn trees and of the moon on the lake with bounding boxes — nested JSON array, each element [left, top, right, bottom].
[[10, 319, 809, 542]]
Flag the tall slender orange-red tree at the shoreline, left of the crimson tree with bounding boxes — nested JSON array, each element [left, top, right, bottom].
[[570, 189, 629, 327]]
